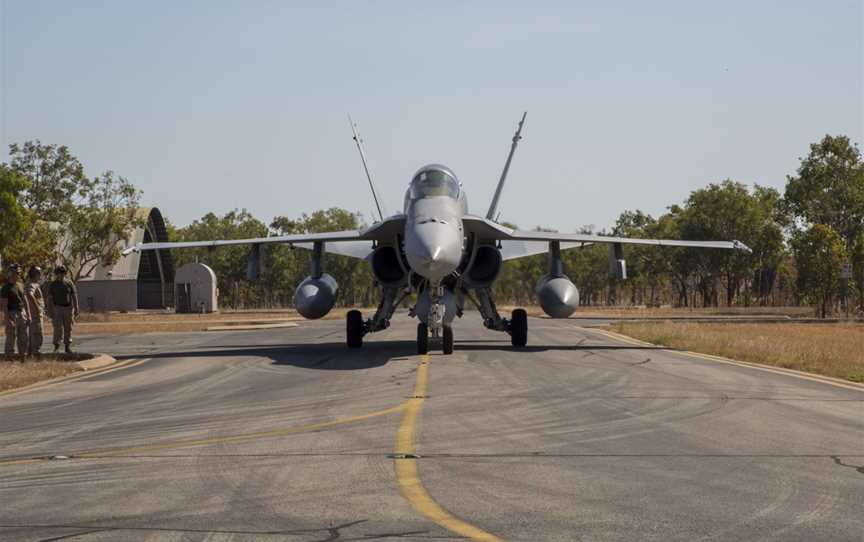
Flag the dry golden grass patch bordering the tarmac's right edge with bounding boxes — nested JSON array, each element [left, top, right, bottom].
[[612, 322, 864, 382]]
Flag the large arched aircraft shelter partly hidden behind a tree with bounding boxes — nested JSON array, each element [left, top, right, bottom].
[[77, 207, 174, 312]]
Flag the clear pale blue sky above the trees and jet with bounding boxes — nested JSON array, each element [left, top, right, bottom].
[[0, 0, 864, 231]]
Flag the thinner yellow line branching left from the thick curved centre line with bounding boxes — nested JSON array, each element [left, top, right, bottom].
[[0, 403, 406, 466]]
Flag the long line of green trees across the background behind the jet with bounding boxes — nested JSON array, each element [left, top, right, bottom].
[[0, 135, 864, 317]]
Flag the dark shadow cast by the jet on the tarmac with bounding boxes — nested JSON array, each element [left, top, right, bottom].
[[135, 340, 663, 371]]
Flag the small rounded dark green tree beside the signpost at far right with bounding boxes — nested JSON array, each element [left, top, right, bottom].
[[792, 224, 846, 318]]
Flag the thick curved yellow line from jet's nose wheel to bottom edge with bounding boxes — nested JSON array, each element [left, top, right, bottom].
[[394, 354, 501, 542]]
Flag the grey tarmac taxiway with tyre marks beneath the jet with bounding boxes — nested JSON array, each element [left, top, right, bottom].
[[0, 313, 864, 542]]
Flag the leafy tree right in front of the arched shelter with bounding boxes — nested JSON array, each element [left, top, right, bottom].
[[60, 171, 146, 280]]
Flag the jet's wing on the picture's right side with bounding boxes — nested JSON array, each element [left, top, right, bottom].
[[465, 216, 752, 254]]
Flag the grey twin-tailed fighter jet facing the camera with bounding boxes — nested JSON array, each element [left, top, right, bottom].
[[124, 114, 750, 354]]
